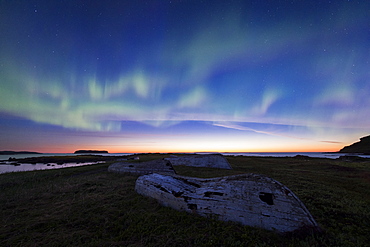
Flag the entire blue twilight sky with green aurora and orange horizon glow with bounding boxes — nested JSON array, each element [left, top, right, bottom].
[[0, 0, 370, 152]]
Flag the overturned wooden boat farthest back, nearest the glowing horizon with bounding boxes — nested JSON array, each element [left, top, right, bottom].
[[165, 154, 232, 169]]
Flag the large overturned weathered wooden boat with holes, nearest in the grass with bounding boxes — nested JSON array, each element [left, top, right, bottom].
[[135, 173, 319, 232]]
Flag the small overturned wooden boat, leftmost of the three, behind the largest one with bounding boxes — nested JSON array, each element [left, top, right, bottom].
[[108, 160, 175, 175]]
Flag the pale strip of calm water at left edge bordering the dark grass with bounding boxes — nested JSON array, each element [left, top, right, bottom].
[[0, 161, 105, 174]]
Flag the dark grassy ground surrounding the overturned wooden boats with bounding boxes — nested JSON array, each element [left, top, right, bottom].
[[0, 154, 370, 246]]
